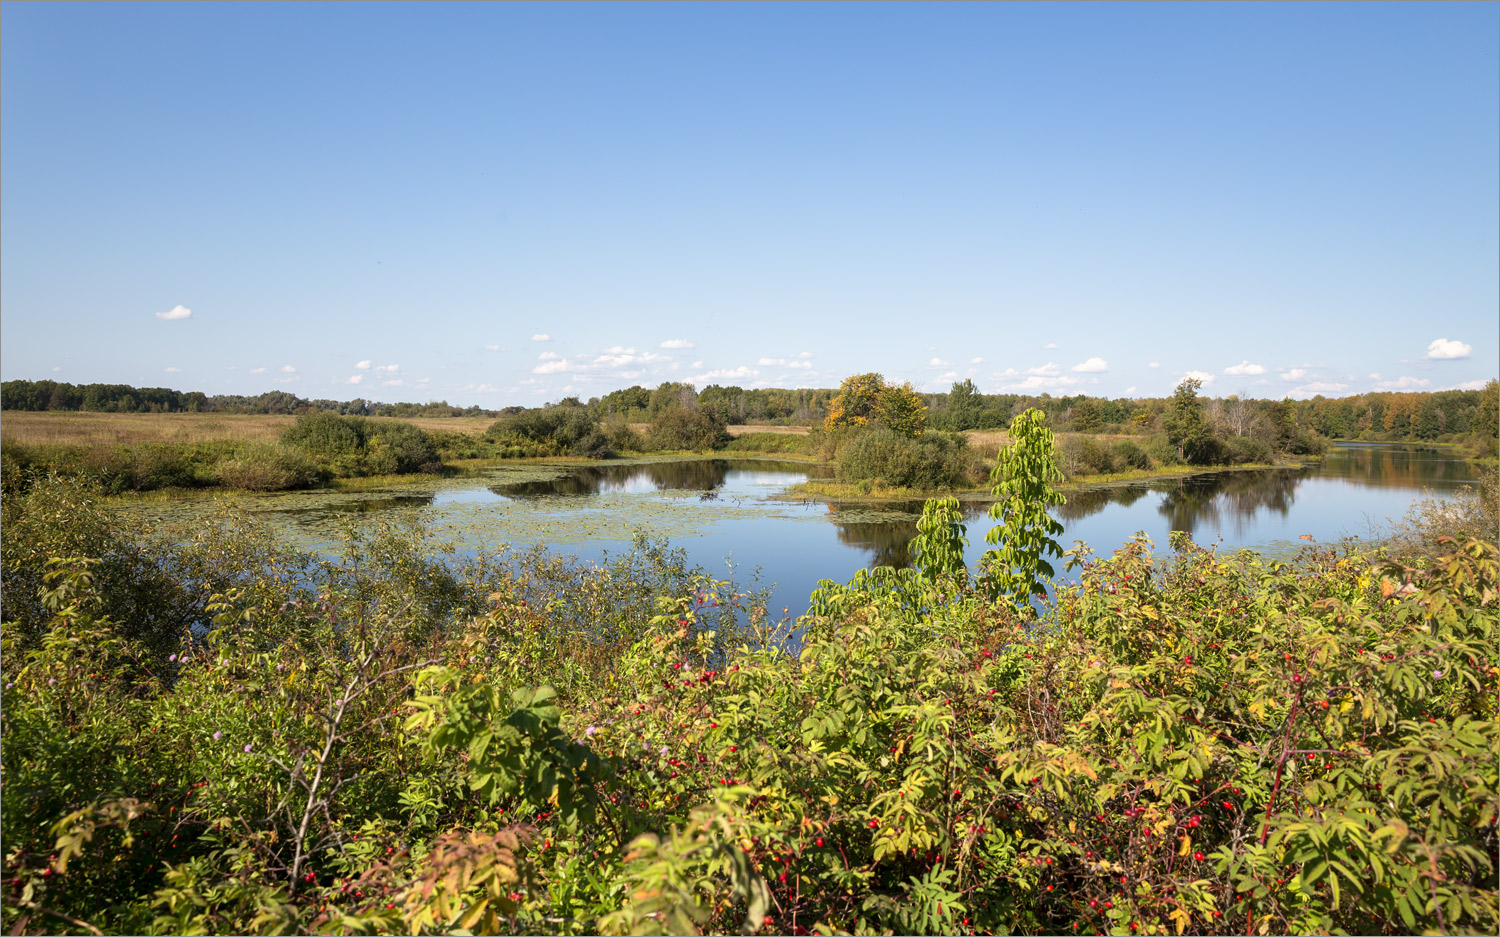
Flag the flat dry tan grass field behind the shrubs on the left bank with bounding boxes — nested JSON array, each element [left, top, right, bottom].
[[0, 409, 494, 445]]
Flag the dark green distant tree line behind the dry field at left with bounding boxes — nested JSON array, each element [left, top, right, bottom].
[[0, 381, 497, 417]]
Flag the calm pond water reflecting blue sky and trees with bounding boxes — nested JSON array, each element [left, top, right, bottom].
[[120, 444, 1473, 615]]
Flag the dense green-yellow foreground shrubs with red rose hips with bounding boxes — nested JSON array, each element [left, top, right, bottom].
[[0, 470, 1500, 934]]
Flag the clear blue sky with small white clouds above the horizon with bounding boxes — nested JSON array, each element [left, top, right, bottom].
[[0, 3, 1500, 406]]
